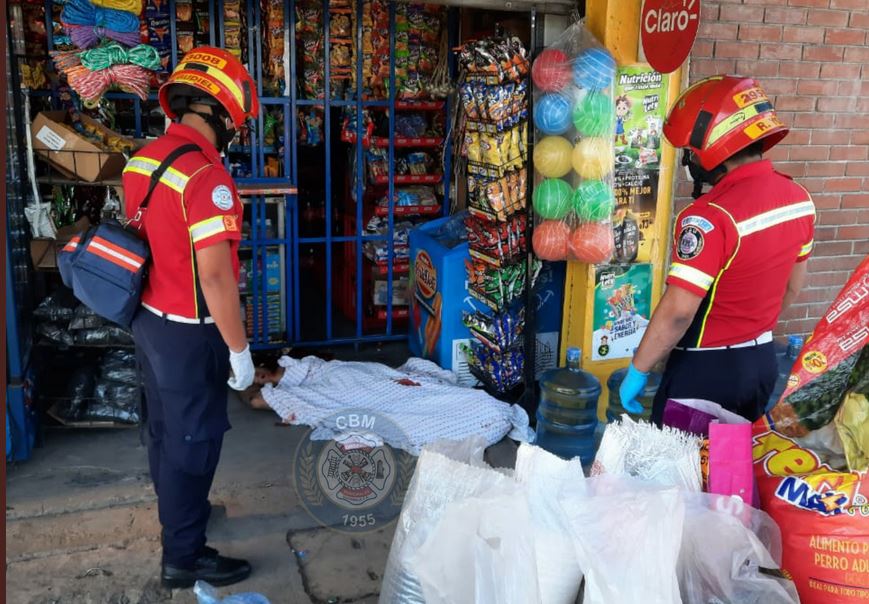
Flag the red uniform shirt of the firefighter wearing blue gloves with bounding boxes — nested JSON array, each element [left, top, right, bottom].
[[667, 160, 815, 348]]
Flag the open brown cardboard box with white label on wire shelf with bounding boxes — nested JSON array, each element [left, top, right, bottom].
[[30, 111, 130, 182]]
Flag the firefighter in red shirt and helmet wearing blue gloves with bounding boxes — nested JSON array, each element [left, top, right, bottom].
[[620, 76, 815, 425]]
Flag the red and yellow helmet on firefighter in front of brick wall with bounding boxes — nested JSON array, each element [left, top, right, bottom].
[[663, 75, 788, 170]]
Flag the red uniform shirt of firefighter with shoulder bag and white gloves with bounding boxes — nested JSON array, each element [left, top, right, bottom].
[[123, 124, 242, 319]]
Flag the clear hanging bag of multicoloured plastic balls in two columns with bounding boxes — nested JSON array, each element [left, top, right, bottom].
[[531, 23, 616, 264]]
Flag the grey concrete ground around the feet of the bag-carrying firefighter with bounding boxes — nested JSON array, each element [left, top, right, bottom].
[[6, 395, 392, 604]]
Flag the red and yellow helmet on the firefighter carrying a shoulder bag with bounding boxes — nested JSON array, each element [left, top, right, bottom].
[[159, 46, 259, 128]]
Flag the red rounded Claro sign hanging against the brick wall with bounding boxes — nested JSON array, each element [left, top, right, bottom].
[[640, 0, 700, 73]]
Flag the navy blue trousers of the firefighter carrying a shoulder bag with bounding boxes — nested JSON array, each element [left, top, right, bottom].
[[133, 309, 230, 568]]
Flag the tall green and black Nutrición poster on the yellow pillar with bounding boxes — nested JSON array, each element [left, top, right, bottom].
[[614, 65, 667, 262]]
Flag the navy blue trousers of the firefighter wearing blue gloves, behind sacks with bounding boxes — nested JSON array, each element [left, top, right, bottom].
[[652, 342, 778, 426]]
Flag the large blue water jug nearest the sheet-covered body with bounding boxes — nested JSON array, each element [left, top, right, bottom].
[[537, 348, 601, 468]]
